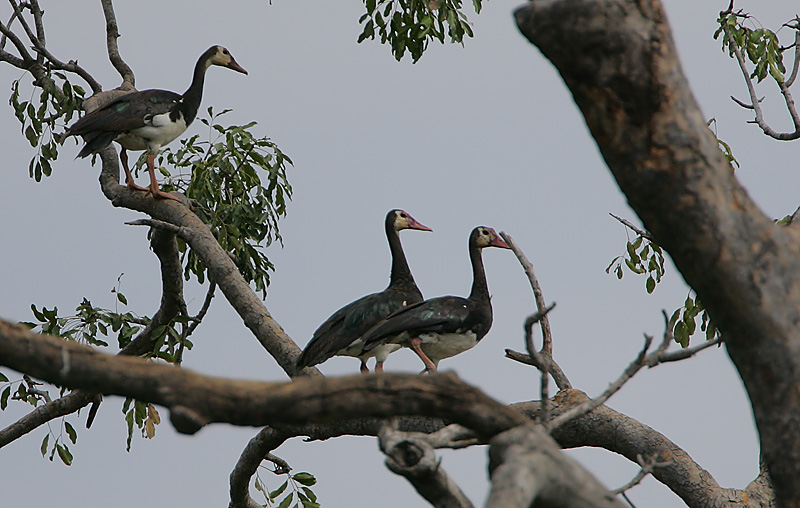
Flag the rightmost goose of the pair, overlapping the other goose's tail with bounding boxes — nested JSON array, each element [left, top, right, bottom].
[[361, 226, 510, 373]]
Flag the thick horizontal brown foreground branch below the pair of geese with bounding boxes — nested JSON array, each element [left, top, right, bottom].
[[0, 321, 525, 437]]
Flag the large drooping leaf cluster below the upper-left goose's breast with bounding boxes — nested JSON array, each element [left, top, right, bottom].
[[157, 108, 292, 297]]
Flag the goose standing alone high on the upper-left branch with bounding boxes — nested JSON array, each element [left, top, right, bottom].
[[62, 46, 247, 202]]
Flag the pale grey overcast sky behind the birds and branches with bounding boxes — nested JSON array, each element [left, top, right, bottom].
[[0, 0, 800, 508]]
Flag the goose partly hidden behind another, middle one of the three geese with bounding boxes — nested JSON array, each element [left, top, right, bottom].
[[297, 210, 431, 374]]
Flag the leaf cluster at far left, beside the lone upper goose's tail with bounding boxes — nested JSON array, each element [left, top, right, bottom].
[[8, 72, 85, 182]]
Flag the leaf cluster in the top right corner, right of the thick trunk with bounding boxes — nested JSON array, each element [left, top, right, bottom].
[[714, 10, 797, 83]]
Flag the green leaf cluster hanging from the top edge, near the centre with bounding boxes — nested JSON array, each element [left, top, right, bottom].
[[358, 0, 483, 62]]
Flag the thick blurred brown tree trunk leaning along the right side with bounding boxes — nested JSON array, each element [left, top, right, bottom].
[[516, 0, 800, 507]]
